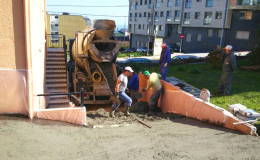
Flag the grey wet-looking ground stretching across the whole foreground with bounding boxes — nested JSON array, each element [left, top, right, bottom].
[[0, 103, 260, 160]]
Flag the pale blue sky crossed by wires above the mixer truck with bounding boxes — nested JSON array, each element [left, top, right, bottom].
[[46, 0, 129, 29]]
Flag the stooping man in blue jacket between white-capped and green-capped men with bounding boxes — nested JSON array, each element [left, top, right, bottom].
[[127, 72, 139, 105]]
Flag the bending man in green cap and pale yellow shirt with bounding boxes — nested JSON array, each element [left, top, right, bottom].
[[143, 71, 162, 113]]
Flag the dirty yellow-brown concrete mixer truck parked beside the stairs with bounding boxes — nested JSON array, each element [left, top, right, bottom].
[[70, 20, 121, 104]]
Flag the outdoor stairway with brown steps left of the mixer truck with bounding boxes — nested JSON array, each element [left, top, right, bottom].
[[46, 48, 69, 108]]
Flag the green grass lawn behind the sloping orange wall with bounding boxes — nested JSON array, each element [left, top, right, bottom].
[[134, 60, 260, 112]]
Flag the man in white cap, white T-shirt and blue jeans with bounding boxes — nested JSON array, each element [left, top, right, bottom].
[[110, 66, 134, 118]]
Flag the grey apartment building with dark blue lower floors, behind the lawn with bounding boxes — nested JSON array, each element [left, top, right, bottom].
[[128, 0, 260, 53]]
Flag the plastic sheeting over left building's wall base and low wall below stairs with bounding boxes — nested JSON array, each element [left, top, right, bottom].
[[0, 69, 86, 125]]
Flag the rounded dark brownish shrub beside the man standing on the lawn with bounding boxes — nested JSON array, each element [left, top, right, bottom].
[[206, 50, 224, 69]]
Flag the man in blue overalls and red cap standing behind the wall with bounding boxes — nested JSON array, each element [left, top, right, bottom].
[[159, 43, 171, 81]]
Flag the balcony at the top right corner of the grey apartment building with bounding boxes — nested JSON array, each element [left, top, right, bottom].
[[230, 0, 260, 10]]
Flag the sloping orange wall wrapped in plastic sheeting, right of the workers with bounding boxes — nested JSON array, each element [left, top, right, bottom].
[[138, 74, 256, 135]]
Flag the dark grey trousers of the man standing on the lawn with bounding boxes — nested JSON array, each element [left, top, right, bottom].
[[218, 72, 233, 95]]
